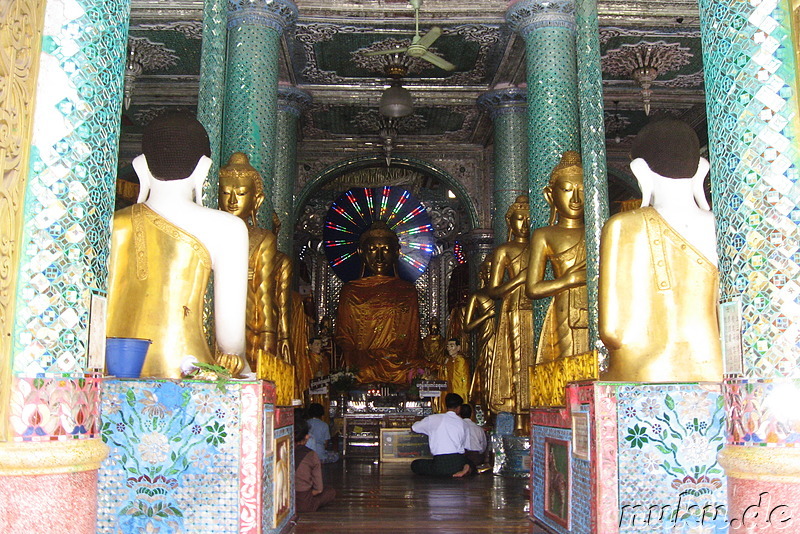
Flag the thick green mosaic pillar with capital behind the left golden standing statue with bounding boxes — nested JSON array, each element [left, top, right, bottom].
[[221, 0, 298, 228]]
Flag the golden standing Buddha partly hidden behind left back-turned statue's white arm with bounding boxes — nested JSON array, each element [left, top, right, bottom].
[[219, 152, 278, 378]]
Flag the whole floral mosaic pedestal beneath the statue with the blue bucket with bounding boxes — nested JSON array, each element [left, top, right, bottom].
[[97, 379, 294, 534]]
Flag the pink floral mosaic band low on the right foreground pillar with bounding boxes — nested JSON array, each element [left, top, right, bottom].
[[723, 379, 800, 447]]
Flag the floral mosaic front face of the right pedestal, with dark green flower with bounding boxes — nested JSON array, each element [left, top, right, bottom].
[[616, 384, 727, 533]]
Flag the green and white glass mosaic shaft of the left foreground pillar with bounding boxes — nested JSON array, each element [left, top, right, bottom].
[[13, 0, 130, 376]]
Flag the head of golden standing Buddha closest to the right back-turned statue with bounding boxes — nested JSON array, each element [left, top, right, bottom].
[[544, 150, 584, 226]]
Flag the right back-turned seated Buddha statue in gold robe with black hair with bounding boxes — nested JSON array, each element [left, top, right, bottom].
[[598, 119, 722, 382]]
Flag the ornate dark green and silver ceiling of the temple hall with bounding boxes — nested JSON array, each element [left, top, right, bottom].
[[121, 0, 707, 214]]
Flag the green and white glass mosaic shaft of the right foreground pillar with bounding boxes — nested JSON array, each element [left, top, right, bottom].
[[700, 0, 800, 378]]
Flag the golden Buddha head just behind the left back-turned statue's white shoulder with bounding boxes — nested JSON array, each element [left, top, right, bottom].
[[219, 152, 264, 225]]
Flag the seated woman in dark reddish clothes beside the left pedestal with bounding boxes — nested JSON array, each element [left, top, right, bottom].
[[294, 419, 336, 512]]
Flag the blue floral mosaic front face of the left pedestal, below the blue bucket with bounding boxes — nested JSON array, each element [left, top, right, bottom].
[[97, 380, 263, 534]]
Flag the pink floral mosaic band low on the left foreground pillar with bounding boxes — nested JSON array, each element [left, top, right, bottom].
[[9, 375, 101, 441]]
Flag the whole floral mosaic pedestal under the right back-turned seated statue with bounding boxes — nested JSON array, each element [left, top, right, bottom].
[[531, 382, 727, 534]]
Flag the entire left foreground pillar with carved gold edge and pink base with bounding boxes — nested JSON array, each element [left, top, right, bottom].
[[0, 0, 130, 533]]
